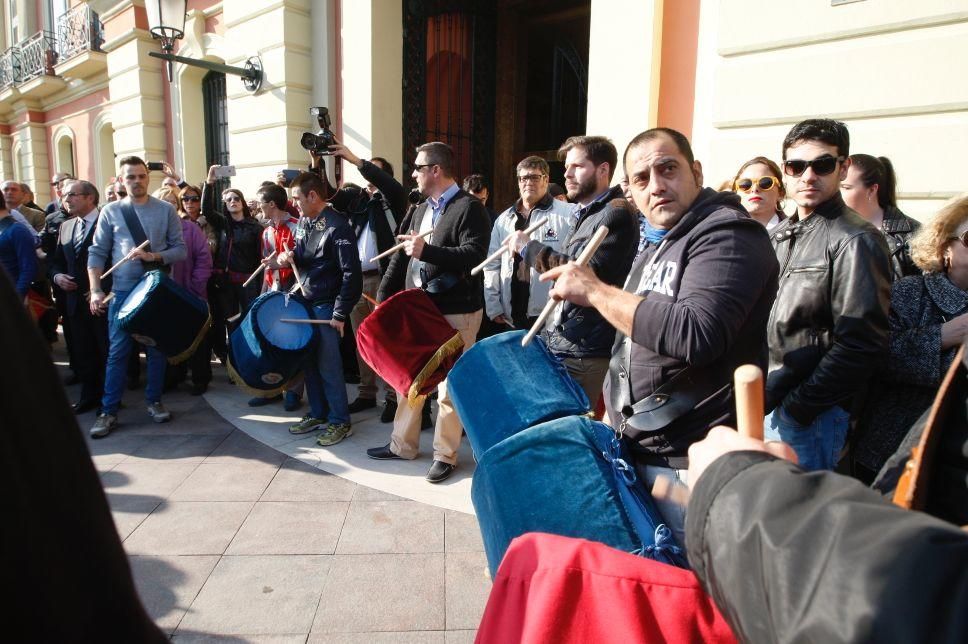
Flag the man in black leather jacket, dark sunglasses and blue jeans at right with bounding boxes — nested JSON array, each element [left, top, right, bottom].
[[765, 119, 891, 470]]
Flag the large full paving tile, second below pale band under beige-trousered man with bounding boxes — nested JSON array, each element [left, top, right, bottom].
[[312, 554, 444, 634]]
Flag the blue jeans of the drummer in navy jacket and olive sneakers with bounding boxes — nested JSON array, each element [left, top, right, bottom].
[[305, 304, 350, 423]]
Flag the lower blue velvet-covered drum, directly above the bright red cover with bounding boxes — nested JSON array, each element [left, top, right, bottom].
[[471, 416, 687, 574]]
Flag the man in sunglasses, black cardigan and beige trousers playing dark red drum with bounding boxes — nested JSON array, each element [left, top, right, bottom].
[[366, 141, 491, 483]]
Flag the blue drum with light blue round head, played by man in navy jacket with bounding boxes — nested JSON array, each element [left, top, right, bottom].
[[228, 291, 318, 397]]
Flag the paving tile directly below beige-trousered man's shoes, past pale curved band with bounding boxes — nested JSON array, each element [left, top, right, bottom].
[[336, 501, 444, 555]]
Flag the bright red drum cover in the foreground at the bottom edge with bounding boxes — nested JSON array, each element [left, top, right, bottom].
[[476, 532, 736, 644]]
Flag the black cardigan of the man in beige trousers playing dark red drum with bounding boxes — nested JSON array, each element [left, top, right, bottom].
[[377, 190, 491, 315]]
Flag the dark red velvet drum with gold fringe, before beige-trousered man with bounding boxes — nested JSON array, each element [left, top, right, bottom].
[[356, 288, 464, 400]]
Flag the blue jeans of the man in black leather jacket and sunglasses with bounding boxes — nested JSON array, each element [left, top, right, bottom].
[[763, 406, 850, 471]]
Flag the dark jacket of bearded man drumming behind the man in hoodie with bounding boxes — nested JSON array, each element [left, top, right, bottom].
[[521, 186, 639, 358]]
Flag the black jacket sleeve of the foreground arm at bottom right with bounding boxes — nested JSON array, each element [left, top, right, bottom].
[[686, 452, 968, 643]]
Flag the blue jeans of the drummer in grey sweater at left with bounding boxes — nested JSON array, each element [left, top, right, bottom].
[[101, 291, 168, 416]]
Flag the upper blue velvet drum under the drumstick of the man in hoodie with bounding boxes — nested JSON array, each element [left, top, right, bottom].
[[447, 331, 591, 458]]
